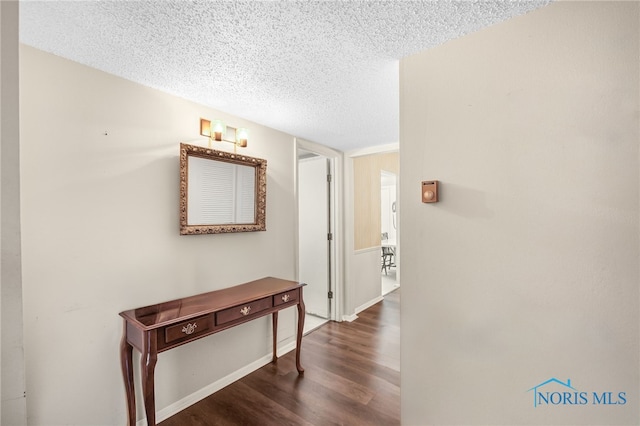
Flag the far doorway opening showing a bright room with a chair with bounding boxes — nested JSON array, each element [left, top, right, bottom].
[[380, 170, 400, 296]]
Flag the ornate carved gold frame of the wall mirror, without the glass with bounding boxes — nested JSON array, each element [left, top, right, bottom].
[[180, 143, 267, 235]]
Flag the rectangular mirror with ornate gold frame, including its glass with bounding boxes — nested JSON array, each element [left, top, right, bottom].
[[180, 143, 267, 235]]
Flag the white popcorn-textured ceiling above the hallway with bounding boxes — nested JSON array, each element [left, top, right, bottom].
[[20, 0, 548, 150]]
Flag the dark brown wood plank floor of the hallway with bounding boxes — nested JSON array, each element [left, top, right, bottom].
[[161, 290, 400, 426]]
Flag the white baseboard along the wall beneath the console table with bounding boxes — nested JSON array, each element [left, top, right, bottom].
[[136, 341, 296, 426]]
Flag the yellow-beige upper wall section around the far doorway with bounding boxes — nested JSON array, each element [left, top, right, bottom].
[[353, 152, 399, 250]]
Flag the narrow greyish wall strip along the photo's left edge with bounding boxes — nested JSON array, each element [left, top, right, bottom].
[[0, 1, 26, 425]]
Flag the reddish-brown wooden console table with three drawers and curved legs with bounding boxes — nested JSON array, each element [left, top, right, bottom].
[[120, 277, 305, 426]]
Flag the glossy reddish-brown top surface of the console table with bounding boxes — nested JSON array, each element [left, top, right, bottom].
[[120, 277, 306, 330]]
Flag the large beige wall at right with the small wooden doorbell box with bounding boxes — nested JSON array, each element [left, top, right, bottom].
[[400, 2, 640, 425]]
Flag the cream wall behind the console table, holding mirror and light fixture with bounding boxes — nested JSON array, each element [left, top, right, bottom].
[[20, 46, 295, 425]]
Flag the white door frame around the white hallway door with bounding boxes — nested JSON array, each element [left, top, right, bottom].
[[294, 138, 344, 321]]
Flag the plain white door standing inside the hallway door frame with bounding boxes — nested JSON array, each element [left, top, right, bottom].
[[298, 155, 331, 318]]
